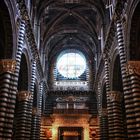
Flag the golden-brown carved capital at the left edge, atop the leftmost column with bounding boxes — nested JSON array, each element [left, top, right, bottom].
[[0, 59, 16, 73]]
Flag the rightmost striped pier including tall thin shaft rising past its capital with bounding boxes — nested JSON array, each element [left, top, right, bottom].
[[116, 18, 140, 140]]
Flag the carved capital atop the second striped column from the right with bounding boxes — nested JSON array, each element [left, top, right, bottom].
[[108, 91, 122, 102]]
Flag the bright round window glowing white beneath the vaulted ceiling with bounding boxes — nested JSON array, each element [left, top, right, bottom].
[[57, 52, 86, 78]]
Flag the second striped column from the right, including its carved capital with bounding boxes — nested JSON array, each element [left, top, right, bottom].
[[108, 91, 125, 140]]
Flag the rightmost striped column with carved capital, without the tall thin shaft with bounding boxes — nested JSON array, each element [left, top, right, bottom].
[[126, 61, 140, 139]]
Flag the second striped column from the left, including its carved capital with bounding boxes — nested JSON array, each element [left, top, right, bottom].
[[15, 91, 32, 140]]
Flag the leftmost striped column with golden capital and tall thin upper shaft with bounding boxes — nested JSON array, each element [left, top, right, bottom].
[[0, 20, 25, 139]]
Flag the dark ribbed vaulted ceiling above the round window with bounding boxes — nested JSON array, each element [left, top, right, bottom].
[[36, 0, 105, 65]]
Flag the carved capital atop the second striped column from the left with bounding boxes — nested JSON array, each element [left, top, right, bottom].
[[17, 91, 32, 101]]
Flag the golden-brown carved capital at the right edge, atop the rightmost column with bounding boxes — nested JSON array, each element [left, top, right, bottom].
[[126, 61, 140, 75]]
